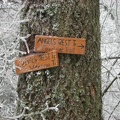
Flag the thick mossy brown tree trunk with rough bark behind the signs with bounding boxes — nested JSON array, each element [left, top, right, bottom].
[[18, 0, 102, 120]]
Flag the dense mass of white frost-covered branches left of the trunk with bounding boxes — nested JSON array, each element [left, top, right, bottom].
[[0, 2, 29, 116]]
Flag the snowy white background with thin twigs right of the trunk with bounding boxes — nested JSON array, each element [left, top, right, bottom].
[[100, 0, 120, 120]]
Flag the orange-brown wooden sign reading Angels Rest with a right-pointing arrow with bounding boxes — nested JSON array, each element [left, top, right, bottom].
[[35, 35, 86, 54]]
